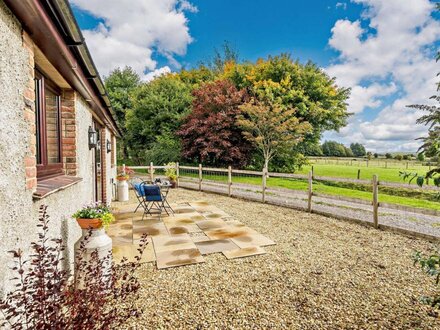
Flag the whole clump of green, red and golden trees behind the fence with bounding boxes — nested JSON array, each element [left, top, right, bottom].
[[105, 45, 351, 171]]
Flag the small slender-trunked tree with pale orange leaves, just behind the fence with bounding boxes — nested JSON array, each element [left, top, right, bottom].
[[237, 100, 312, 169]]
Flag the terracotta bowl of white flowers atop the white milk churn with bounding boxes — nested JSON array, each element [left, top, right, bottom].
[[72, 202, 115, 229]]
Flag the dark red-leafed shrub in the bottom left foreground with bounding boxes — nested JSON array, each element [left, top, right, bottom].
[[0, 206, 147, 330]]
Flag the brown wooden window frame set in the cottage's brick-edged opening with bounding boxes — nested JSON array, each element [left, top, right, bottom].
[[35, 69, 64, 179]]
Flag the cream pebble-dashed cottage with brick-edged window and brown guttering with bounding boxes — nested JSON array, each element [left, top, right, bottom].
[[0, 0, 120, 295]]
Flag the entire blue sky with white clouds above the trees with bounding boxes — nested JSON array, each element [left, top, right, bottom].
[[71, 0, 440, 151]]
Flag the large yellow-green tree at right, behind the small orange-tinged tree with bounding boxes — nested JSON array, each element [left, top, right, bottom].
[[222, 54, 350, 148]]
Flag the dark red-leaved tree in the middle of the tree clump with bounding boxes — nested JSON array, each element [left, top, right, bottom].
[[177, 80, 252, 167]]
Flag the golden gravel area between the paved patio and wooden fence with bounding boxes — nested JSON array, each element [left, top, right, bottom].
[[127, 189, 440, 329]]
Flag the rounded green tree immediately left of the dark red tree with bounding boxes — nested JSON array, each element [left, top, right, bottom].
[[126, 74, 192, 164]]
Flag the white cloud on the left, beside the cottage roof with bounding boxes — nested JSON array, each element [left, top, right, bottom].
[[72, 0, 197, 79]]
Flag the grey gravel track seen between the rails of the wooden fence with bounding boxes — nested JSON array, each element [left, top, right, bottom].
[[181, 181, 440, 238]]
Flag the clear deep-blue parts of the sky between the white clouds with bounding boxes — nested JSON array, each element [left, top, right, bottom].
[[73, 0, 362, 70]]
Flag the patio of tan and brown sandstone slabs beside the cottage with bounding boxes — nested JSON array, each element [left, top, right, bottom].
[[107, 192, 275, 269]]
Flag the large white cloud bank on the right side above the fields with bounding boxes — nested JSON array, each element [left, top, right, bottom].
[[326, 0, 440, 151]]
